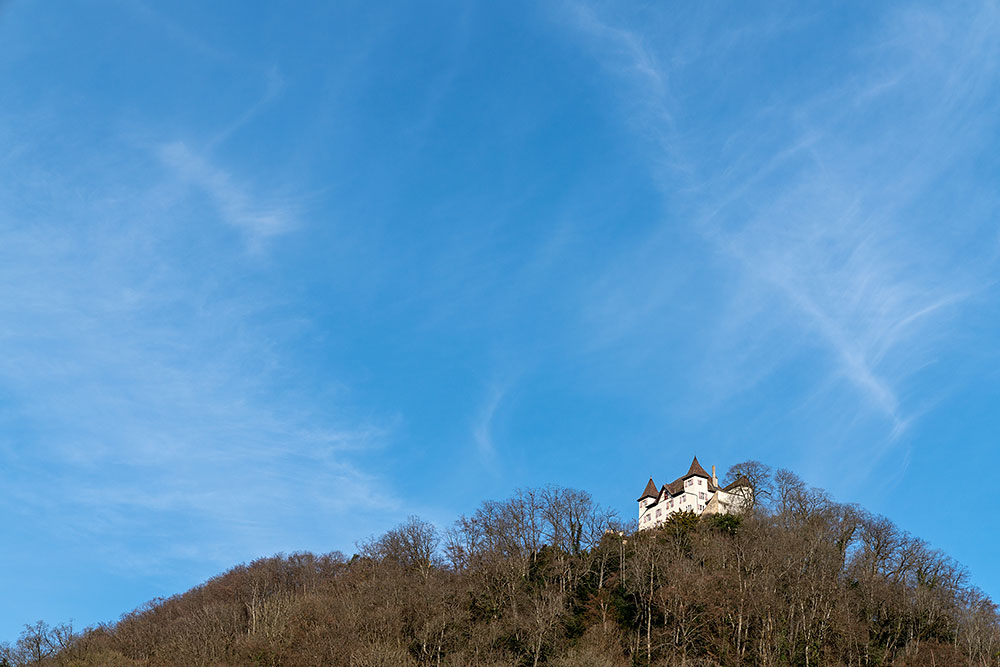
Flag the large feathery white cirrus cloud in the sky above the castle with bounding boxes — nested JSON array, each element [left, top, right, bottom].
[[571, 3, 998, 460]]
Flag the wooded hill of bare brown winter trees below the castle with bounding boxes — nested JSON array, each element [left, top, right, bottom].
[[0, 462, 1000, 667]]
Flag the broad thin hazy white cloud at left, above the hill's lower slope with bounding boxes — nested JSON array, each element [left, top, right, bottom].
[[0, 130, 382, 572]]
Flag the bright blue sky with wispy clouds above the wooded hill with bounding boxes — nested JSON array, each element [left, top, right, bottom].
[[0, 0, 1000, 639]]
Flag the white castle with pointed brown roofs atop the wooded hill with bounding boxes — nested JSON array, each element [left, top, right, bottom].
[[639, 456, 753, 530]]
